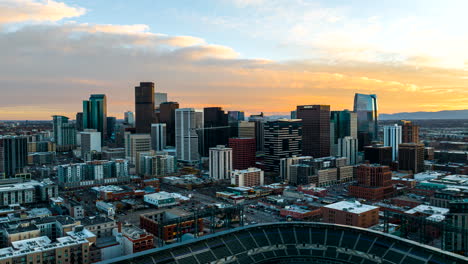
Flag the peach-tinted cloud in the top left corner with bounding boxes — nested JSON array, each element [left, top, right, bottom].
[[0, 0, 86, 24]]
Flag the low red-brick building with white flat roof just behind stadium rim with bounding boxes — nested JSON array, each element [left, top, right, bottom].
[[322, 201, 379, 228]]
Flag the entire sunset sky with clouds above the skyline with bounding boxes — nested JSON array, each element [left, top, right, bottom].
[[0, 0, 468, 120]]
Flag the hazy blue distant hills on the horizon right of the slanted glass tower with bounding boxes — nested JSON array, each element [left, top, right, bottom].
[[379, 110, 468, 120]]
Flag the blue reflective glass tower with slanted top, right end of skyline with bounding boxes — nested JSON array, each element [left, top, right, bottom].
[[354, 93, 379, 151]]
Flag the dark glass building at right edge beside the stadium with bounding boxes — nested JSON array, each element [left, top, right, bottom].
[[442, 198, 468, 255]]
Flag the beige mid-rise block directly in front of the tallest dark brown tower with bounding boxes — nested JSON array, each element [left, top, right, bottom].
[[125, 131, 151, 165]]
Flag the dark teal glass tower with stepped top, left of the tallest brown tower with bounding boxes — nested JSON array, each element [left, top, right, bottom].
[[83, 94, 107, 144]]
